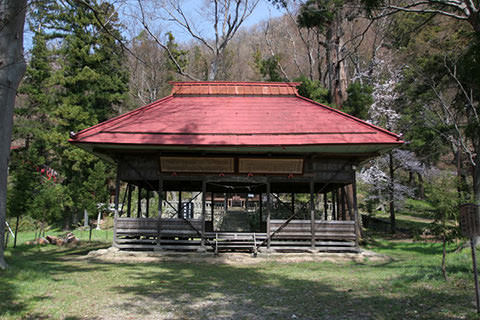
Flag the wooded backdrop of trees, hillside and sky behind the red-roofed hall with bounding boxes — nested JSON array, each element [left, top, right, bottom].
[[7, 0, 480, 248]]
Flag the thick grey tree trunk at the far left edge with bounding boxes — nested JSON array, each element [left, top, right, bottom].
[[0, 0, 27, 269]]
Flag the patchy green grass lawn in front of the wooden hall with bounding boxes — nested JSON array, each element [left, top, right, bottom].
[[0, 231, 478, 319]]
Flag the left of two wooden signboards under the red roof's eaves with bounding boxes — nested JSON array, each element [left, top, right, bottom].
[[160, 157, 235, 173]]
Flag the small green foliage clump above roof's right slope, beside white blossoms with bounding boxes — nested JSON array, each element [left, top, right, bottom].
[[342, 81, 373, 119]]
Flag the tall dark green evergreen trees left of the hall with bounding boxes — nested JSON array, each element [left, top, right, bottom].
[[10, 0, 127, 229]]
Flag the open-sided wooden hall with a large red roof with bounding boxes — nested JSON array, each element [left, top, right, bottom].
[[70, 82, 403, 253]]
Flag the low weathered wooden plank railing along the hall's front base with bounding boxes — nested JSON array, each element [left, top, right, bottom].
[[114, 218, 359, 253]]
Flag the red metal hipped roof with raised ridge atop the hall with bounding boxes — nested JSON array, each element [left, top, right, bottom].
[[70, 82, 402, 146]]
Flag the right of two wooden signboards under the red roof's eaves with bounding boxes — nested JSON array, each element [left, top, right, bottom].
[[238, 158, 303, 174]]
